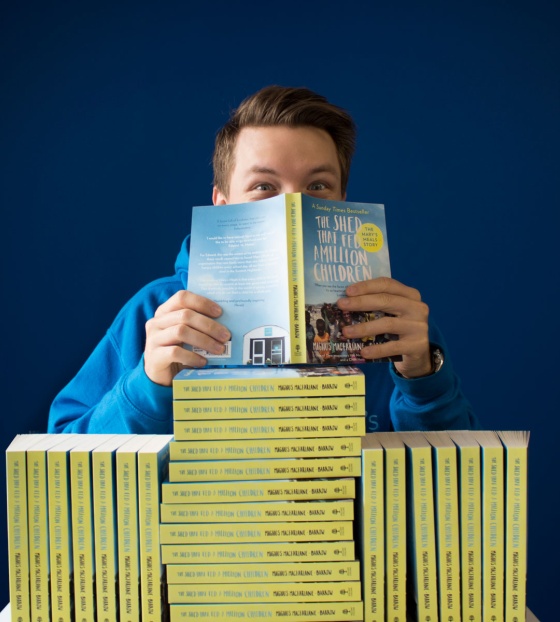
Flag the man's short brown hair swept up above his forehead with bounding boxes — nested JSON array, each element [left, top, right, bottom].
[[212, 85, 356, 196]]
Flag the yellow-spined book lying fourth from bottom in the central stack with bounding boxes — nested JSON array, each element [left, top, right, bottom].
[[161, 540, 356, 564]]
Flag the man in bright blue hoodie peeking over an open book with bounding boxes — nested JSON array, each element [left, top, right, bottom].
[[49, 86, 477, 433]]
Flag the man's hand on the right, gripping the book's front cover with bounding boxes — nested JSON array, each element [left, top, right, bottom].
[[337, 277, 432, 378]]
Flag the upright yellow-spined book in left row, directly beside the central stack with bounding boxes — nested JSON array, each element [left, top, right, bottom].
[[138, 434, 173, 622]]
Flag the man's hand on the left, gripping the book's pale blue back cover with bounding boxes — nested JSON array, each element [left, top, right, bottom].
[[144, 290, 230, 386]]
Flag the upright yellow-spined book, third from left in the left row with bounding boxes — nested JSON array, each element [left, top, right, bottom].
[[47, 434, 83, 622]]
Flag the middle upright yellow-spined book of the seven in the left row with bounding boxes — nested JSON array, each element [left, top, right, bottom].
[[70, 434, 114, 620]]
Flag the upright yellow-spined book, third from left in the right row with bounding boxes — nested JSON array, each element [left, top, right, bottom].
[[399, 432, 438, 622]]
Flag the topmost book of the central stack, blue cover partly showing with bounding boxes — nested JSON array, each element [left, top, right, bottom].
[[173, 365, 366, 400]]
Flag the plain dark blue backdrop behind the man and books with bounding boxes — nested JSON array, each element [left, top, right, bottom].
[[0, 0, 560, 620]]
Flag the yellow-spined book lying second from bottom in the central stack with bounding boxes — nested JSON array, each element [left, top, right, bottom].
[[167, 581, 361, 604]]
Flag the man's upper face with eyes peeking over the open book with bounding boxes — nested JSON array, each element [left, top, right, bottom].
[[212, 125, 346, 205]]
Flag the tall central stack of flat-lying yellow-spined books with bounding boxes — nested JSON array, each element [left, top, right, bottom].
[[160, 367, 365, 622]]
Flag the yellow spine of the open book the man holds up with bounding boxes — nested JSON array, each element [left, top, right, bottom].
[[286, 194, 306, 364]]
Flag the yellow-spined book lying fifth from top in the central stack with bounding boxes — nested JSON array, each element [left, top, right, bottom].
[[169, 456, 361, 482]]
